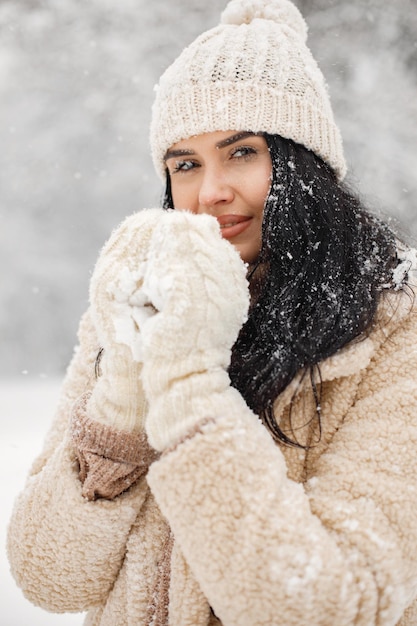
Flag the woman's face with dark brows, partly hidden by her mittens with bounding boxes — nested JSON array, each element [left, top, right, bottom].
[[165, 131, 272, 263]]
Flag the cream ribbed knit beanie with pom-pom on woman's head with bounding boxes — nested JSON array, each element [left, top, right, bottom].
[[150, 0, 346, 180]]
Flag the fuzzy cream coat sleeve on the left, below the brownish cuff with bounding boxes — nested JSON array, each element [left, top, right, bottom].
[[7, 313, 148, 612]]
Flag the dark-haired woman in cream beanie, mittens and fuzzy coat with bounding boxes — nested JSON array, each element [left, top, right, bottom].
[[8, 0, 417, 626]]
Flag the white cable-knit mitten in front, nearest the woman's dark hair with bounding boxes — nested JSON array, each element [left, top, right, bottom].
[[136, 211, 249, 451]]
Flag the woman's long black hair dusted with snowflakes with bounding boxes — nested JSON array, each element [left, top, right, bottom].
[[164, 134, 396, 445]]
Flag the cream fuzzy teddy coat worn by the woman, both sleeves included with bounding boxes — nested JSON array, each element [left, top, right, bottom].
[[8, 284, 417, 626]]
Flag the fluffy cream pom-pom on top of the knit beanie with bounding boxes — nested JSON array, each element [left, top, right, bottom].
[[220, 0, 307, 41]]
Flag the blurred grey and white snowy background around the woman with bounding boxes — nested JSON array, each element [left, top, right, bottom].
[[0, 0, 417, 626]]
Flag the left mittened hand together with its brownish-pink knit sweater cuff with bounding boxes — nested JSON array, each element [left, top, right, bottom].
[[71, 209, 163, 500]]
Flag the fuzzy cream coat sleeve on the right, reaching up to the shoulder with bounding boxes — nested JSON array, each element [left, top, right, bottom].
[[148, 298, 417, 626]]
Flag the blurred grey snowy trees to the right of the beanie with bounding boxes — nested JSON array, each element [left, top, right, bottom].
[[297, 0, 417, 235]]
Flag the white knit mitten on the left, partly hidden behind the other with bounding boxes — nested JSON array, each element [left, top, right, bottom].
[[86, 209, 165, 432]]
